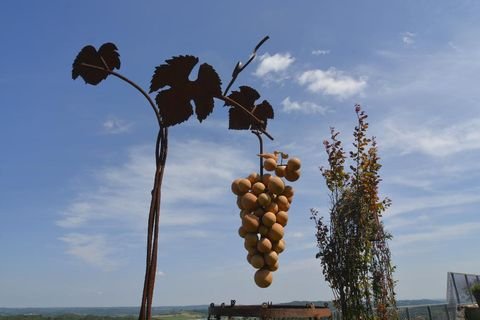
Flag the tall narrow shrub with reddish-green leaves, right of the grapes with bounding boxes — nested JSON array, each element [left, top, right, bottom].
[[311, 105, 396, 319]]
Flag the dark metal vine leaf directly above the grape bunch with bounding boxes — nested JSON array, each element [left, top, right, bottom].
[[227, 86, 274, 130]]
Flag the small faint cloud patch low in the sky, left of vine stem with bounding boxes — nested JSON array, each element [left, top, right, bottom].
[[60, 233, 116, 271]]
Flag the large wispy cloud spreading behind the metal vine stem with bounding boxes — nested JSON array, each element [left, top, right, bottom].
[[56, 140, 255, 266]]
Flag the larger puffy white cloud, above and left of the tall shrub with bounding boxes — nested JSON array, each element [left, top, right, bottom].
[[298, 68, 367, 99]]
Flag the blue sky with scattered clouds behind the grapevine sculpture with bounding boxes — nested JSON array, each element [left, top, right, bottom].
[[0, 1, 480, 307]]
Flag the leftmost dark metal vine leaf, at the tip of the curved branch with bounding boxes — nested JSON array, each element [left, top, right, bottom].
[[72, 42, 120, 85]]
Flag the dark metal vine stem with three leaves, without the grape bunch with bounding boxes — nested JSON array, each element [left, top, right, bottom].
[[72, 36, 282, 320]]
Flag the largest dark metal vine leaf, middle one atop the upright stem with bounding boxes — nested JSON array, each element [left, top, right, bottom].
[[150, 55, 222, 127]]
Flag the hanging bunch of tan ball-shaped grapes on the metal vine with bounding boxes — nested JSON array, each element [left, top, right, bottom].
[[231, 151, 301, 288]]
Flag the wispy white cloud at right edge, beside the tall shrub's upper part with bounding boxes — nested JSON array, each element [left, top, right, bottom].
[[382, 118, 480, 157]]
